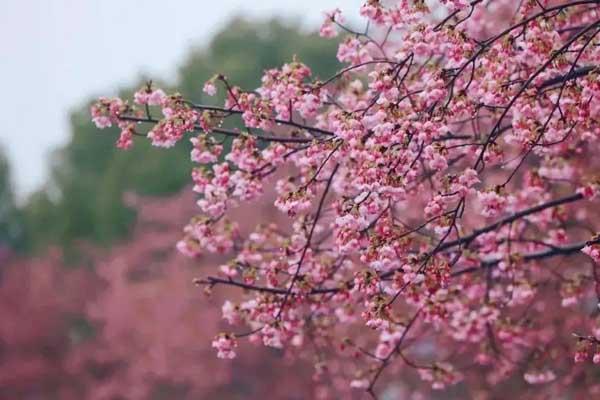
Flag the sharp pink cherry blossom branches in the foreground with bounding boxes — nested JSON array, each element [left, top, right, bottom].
[[92, 0, 600, 397]]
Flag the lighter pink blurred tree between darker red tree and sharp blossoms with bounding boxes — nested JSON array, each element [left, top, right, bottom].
[[69, 192, 336, 400]]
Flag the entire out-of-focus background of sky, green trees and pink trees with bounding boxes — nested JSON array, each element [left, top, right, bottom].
[[0, 0, 361, 399]]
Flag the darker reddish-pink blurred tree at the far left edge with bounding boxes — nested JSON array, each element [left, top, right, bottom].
[[0, 251, 98, 399]]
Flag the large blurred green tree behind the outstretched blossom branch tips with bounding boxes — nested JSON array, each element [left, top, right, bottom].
[[17, 18, 338, 250]]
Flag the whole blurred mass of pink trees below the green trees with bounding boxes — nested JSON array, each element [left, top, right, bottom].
[[0, 192, 354, 400]]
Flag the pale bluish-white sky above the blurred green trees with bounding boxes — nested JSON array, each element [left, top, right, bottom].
[[0, 0, 363, 197]]
